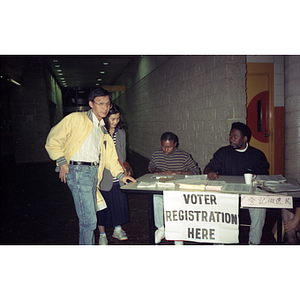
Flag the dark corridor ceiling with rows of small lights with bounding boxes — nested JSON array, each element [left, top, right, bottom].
[[46, 55, 134, 88]]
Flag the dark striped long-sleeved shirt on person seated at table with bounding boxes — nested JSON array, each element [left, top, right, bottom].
[[148, 148, 200, 175]]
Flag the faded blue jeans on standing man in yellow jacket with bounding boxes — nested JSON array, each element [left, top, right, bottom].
[[66, 165, 98, 245]]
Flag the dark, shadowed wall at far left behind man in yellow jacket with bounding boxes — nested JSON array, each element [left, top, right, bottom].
[[10, 56, 61, 163]]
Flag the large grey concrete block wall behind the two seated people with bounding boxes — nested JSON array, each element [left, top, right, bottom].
[[114, 56, 246, 171]]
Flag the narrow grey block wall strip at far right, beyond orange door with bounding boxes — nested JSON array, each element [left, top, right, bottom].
[[285, 56, 300, 182]]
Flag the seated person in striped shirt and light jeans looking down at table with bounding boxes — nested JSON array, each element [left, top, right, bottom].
[[148, 132, 201, 244]]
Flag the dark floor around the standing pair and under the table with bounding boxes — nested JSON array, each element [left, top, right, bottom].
[[0, 153, 277, 245]]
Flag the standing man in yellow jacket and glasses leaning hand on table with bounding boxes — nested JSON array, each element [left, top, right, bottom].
[[45, 88, 136, 245]]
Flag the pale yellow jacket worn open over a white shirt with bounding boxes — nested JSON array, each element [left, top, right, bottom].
[[45, 110, 124, 210]]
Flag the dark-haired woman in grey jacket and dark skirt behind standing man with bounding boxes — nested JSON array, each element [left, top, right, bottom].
[[97, 104, 129, 245]]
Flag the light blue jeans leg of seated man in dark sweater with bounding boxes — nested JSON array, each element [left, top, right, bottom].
[[249, 208, 266, 245]]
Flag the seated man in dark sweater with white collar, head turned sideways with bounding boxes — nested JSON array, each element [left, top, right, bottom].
[[203, 122, 269, 244]]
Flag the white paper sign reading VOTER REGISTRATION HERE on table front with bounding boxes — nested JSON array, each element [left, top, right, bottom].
[[164, 191, 239, 244]]
